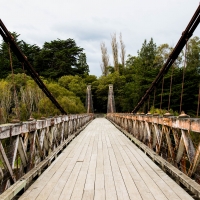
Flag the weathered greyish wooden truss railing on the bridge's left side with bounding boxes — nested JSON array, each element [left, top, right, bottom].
[[0, 114, 93, 194]]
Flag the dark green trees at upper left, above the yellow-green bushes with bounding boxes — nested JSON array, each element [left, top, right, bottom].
[[0, 33, 89, 80]]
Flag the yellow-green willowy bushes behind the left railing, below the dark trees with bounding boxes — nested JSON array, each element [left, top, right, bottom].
[[0, 74, 85, 123]]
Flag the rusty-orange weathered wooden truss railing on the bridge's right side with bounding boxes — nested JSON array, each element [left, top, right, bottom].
[[107, 113, 200, 195]]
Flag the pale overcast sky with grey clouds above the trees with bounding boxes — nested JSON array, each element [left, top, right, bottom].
[[0, 0, 200, 76]]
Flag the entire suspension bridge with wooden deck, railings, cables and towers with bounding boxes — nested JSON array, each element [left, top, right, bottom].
[[0, 3, 200, 200]]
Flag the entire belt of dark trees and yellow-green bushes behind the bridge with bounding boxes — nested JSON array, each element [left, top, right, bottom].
[[0, 34, 200, 123]]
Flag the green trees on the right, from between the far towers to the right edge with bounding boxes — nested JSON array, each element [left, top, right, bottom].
[[92, 37, 200, 116]]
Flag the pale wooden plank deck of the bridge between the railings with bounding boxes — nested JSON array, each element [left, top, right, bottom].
[[19, 118, 193, 200]]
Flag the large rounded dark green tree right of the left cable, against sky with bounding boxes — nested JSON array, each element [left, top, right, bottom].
[[36, 38, 89, 79]]
